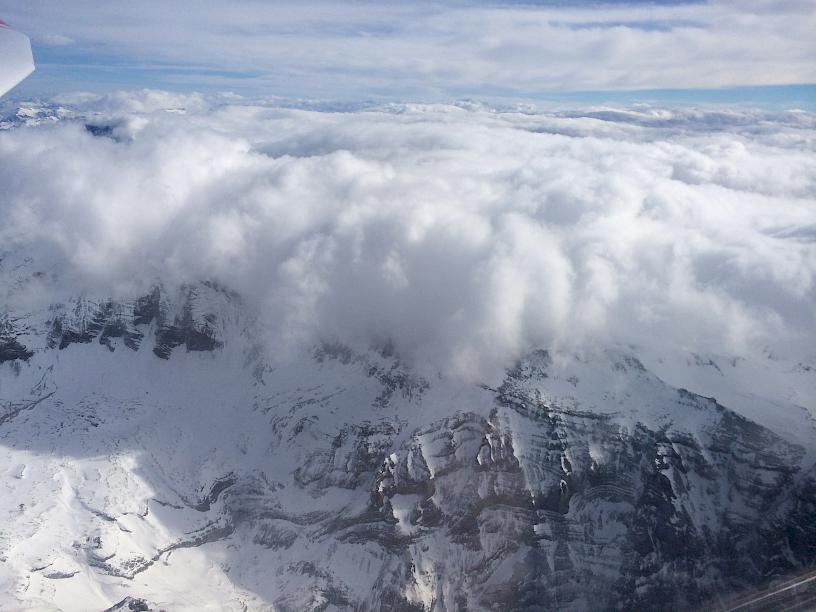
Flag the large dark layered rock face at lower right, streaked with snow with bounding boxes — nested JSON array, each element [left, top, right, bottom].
[[135, 351, 816, 610]]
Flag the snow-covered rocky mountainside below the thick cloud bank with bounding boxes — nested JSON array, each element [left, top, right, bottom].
[[0, 283, 816, 611]]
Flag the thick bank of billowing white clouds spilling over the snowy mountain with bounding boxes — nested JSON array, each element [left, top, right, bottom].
[[0, 92, 816, 373]]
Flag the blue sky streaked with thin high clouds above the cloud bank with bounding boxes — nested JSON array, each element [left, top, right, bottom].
[[0, 0, 816, 108]]
